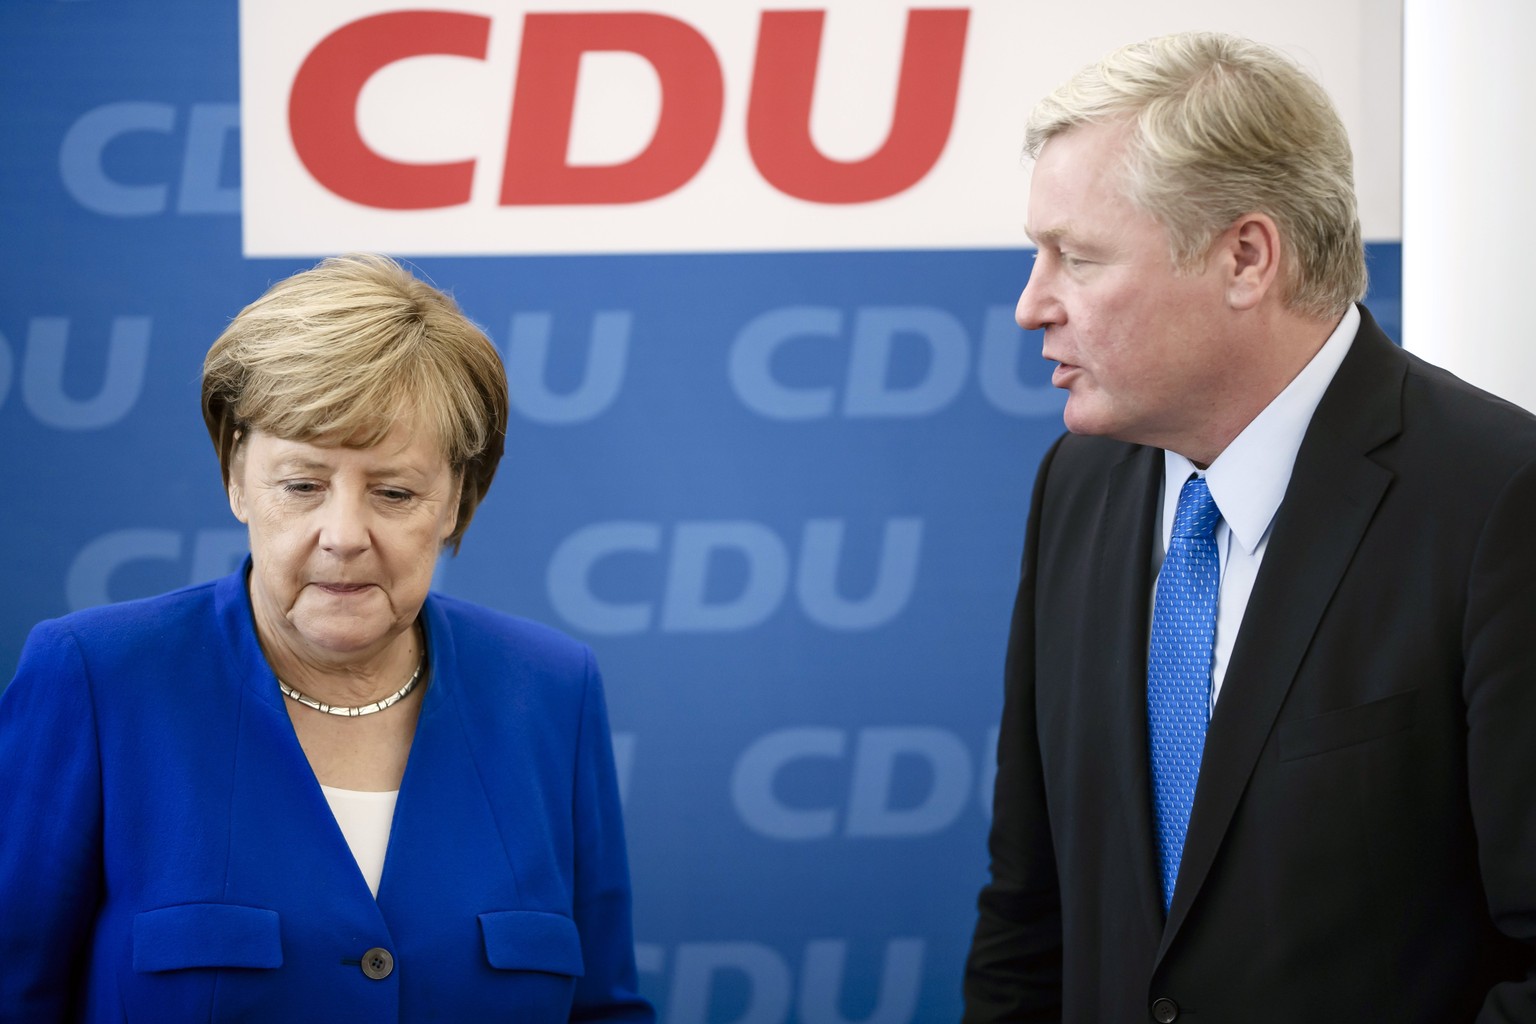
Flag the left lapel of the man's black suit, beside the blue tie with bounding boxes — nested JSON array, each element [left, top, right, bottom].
[[1084, 448, 1163, 933]]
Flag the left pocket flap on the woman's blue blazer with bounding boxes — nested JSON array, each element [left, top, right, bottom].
[[134, 903, 283, 973]]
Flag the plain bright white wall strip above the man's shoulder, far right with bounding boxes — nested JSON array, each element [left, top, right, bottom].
[[1402, 0, 1536, 408]]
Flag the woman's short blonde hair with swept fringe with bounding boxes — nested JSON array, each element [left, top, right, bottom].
[[203, 253, 508, 551]]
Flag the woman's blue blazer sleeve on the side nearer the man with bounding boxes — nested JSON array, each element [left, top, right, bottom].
[[571, 651, 656, 1024]]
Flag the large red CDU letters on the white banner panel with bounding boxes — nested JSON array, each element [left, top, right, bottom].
[[287, 9, 969, 210]]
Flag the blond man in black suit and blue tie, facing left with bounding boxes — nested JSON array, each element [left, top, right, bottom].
[[965, 34, 1536, 1024]]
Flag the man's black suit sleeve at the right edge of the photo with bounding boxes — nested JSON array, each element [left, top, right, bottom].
[[1462, 464, 1536, 1024]]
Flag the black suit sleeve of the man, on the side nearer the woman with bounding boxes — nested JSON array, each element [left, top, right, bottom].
[[965, 441, 1061, 1024]]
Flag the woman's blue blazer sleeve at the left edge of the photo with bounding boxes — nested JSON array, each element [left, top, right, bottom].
[[0, 622, 101, 1022]]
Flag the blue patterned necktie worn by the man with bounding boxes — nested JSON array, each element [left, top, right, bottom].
[[1147, 476, 1221, 913]]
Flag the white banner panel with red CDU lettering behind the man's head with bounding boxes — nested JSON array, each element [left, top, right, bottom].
[[240, 0, 1399, 256]]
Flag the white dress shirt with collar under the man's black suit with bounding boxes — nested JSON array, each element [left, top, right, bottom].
[[1152, 306, 1359, 709]]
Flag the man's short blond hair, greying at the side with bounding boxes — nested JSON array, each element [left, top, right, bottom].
[[1025, 32, 1366, 318]]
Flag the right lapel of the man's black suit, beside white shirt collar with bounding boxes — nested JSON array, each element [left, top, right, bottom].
[[1158, 309, 1405, 960]]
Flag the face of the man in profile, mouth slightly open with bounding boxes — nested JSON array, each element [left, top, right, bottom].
[[1017, 123, 1233, 451]]
